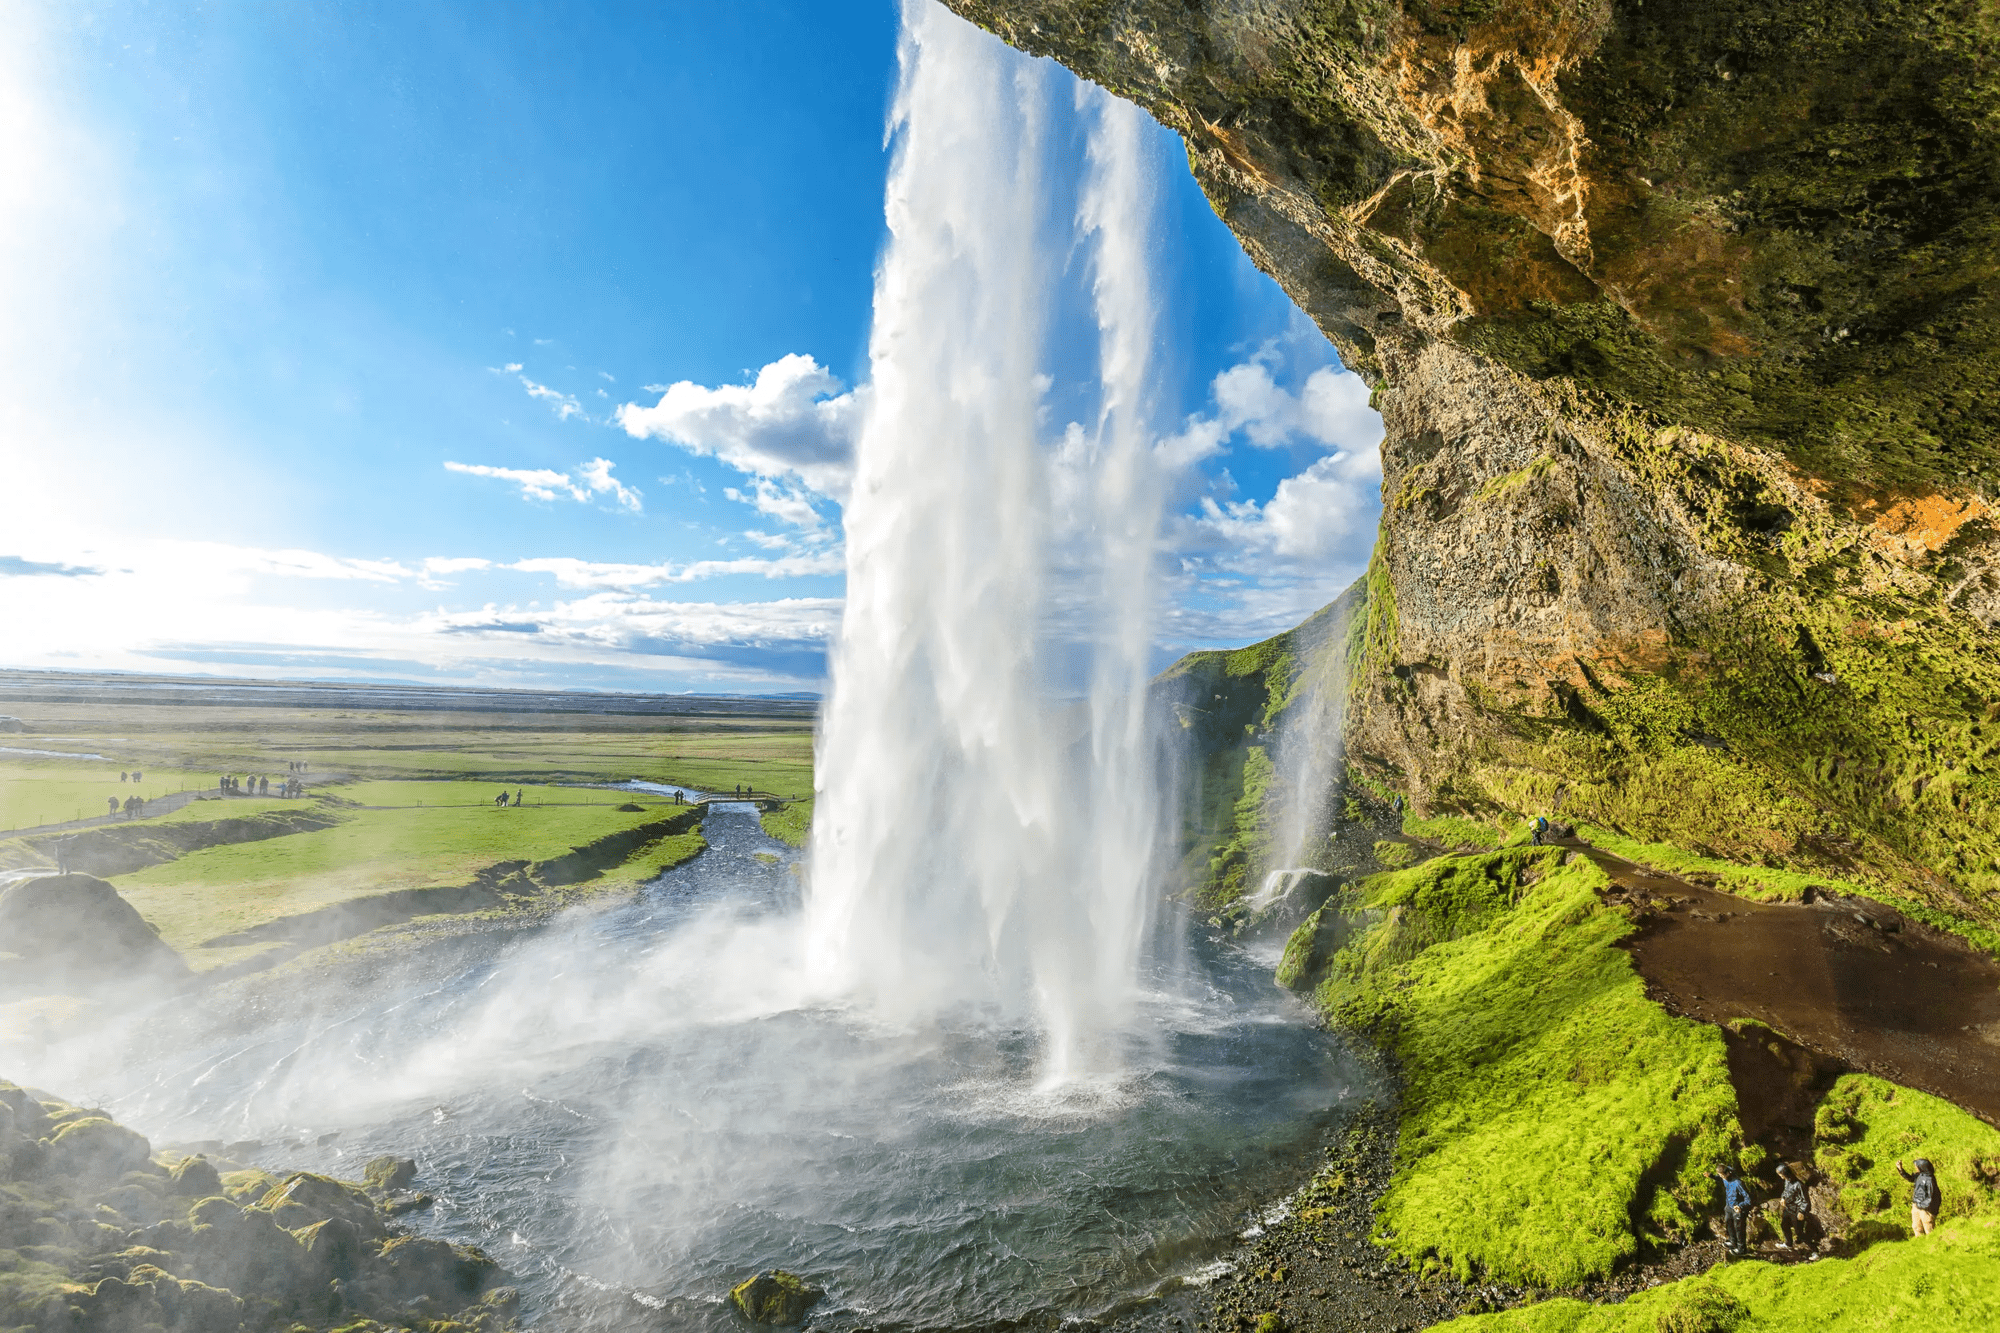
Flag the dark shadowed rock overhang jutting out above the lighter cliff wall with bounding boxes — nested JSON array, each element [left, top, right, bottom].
[[948, 0, 2000, 512]]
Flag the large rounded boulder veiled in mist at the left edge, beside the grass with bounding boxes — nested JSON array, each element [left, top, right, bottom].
[[0, 875, 192, 989]]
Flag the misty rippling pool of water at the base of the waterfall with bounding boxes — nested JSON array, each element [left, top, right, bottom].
[[46, 805, 1372, 1329]]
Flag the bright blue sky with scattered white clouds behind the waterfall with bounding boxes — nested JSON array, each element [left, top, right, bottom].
[[0, 0, 1378, 693]]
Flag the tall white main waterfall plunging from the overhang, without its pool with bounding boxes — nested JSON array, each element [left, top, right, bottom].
[[806, 0, 1160, 1083]]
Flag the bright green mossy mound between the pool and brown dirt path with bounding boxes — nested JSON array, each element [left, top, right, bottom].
[[1316, 849, 1738, 1287]]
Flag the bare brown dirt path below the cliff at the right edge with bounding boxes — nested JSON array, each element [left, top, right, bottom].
[[1560, 839, 2000, 1137]]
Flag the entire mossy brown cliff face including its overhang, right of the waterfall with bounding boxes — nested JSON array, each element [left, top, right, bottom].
[[948, 0, 2000, 923]]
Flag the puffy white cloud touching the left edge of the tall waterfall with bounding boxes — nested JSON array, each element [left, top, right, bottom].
[[616, 352, 864, 500]]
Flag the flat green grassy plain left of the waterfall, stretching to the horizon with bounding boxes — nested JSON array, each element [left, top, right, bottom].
[[0, 673, 812, 971]]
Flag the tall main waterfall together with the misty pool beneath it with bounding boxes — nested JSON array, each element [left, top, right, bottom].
[[8, 4, 1372, 1329]]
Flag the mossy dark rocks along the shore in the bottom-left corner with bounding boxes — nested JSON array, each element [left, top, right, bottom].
[[0, 1083, 518, 1333]]
